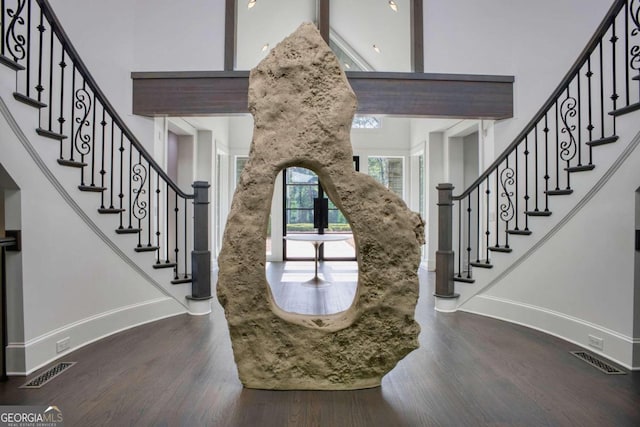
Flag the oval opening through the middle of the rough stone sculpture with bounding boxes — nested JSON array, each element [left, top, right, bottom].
[[266, 166, 358, 315]]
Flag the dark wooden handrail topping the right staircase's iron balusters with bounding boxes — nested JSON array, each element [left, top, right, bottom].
[[453, 0, 626, 200]]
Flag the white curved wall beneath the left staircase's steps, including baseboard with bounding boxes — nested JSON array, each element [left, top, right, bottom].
[[0, 97, 185, 374]]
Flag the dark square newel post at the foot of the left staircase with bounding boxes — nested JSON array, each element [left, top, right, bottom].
[[188, 181, 211, 300]]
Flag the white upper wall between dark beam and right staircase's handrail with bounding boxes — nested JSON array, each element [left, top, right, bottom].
[[424, 0, 612, 154]]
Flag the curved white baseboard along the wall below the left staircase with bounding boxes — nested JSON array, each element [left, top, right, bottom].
[[7, 297, 186, 375]]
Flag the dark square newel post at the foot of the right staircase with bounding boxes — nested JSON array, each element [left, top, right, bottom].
[[435, 184, 458, 298]]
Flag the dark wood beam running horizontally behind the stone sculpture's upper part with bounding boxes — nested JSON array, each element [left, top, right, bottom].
[[131, 71, 513, 119]]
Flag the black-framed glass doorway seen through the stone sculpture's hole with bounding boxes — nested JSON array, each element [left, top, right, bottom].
[[283, 156, 360, 261]]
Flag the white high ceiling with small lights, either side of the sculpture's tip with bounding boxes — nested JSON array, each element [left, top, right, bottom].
[[236, 0, 411, 71]]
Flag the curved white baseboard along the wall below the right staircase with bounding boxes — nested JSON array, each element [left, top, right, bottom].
[[458, 295, 640, 370]]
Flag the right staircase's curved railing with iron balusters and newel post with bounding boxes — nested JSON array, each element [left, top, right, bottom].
[[435, 0, 640, 298]]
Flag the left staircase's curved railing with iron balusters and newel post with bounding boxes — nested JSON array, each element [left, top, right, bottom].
[[0, 0, 211, 299]]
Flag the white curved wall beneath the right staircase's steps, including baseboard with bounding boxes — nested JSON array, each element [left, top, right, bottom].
[[461, 114, 640, 368]]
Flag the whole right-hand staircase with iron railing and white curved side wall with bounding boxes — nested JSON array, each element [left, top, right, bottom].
[[435, 0, 640, 366]]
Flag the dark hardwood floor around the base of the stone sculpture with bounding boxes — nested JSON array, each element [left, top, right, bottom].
[[0, 266, 640, 427]]
